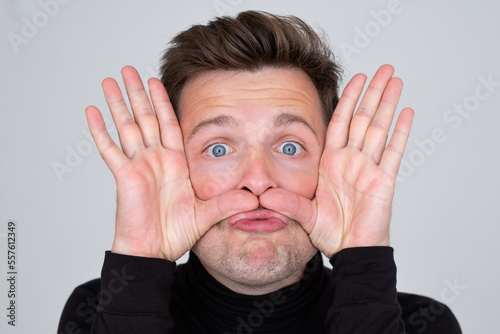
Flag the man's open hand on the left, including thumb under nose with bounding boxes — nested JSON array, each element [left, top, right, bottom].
[[86, 67, 258, 261]]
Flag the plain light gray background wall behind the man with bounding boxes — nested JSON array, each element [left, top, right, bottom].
[[0, 0, 500, 334]]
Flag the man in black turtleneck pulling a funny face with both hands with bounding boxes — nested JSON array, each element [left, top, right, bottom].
[[59, 12, 460, 334]]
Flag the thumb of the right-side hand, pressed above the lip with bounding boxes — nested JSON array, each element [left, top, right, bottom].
[[259, 188, 317, 234]]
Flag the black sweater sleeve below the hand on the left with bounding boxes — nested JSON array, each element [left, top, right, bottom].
[[91, 252, 175, 334]]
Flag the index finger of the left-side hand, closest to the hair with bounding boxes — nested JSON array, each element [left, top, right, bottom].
[[148, 78, 184, 151]]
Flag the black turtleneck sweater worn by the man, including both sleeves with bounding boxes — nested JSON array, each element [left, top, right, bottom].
[[58, 247, 461, 334]]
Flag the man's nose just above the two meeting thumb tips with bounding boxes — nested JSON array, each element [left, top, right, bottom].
[[238, 151, 277, 196]]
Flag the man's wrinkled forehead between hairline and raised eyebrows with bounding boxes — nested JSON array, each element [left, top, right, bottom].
[[179, 68, 322, 131]]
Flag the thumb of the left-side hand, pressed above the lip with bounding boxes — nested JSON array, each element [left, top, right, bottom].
[[196, 190, 259, 233]]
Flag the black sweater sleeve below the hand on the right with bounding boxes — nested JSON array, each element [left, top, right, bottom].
[[326, 247, 406, 334]]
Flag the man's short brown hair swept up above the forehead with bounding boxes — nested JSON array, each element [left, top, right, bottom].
[[160, 11, 341, 124]]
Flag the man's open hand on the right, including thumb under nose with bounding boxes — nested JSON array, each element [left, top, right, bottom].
[[260, 65, 413, 258]]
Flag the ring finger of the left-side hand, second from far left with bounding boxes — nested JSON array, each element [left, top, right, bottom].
[[102, 78, 144, 158]]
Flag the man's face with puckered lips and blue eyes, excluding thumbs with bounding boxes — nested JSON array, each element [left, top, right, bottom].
[[179, 68, 326, 294]]
